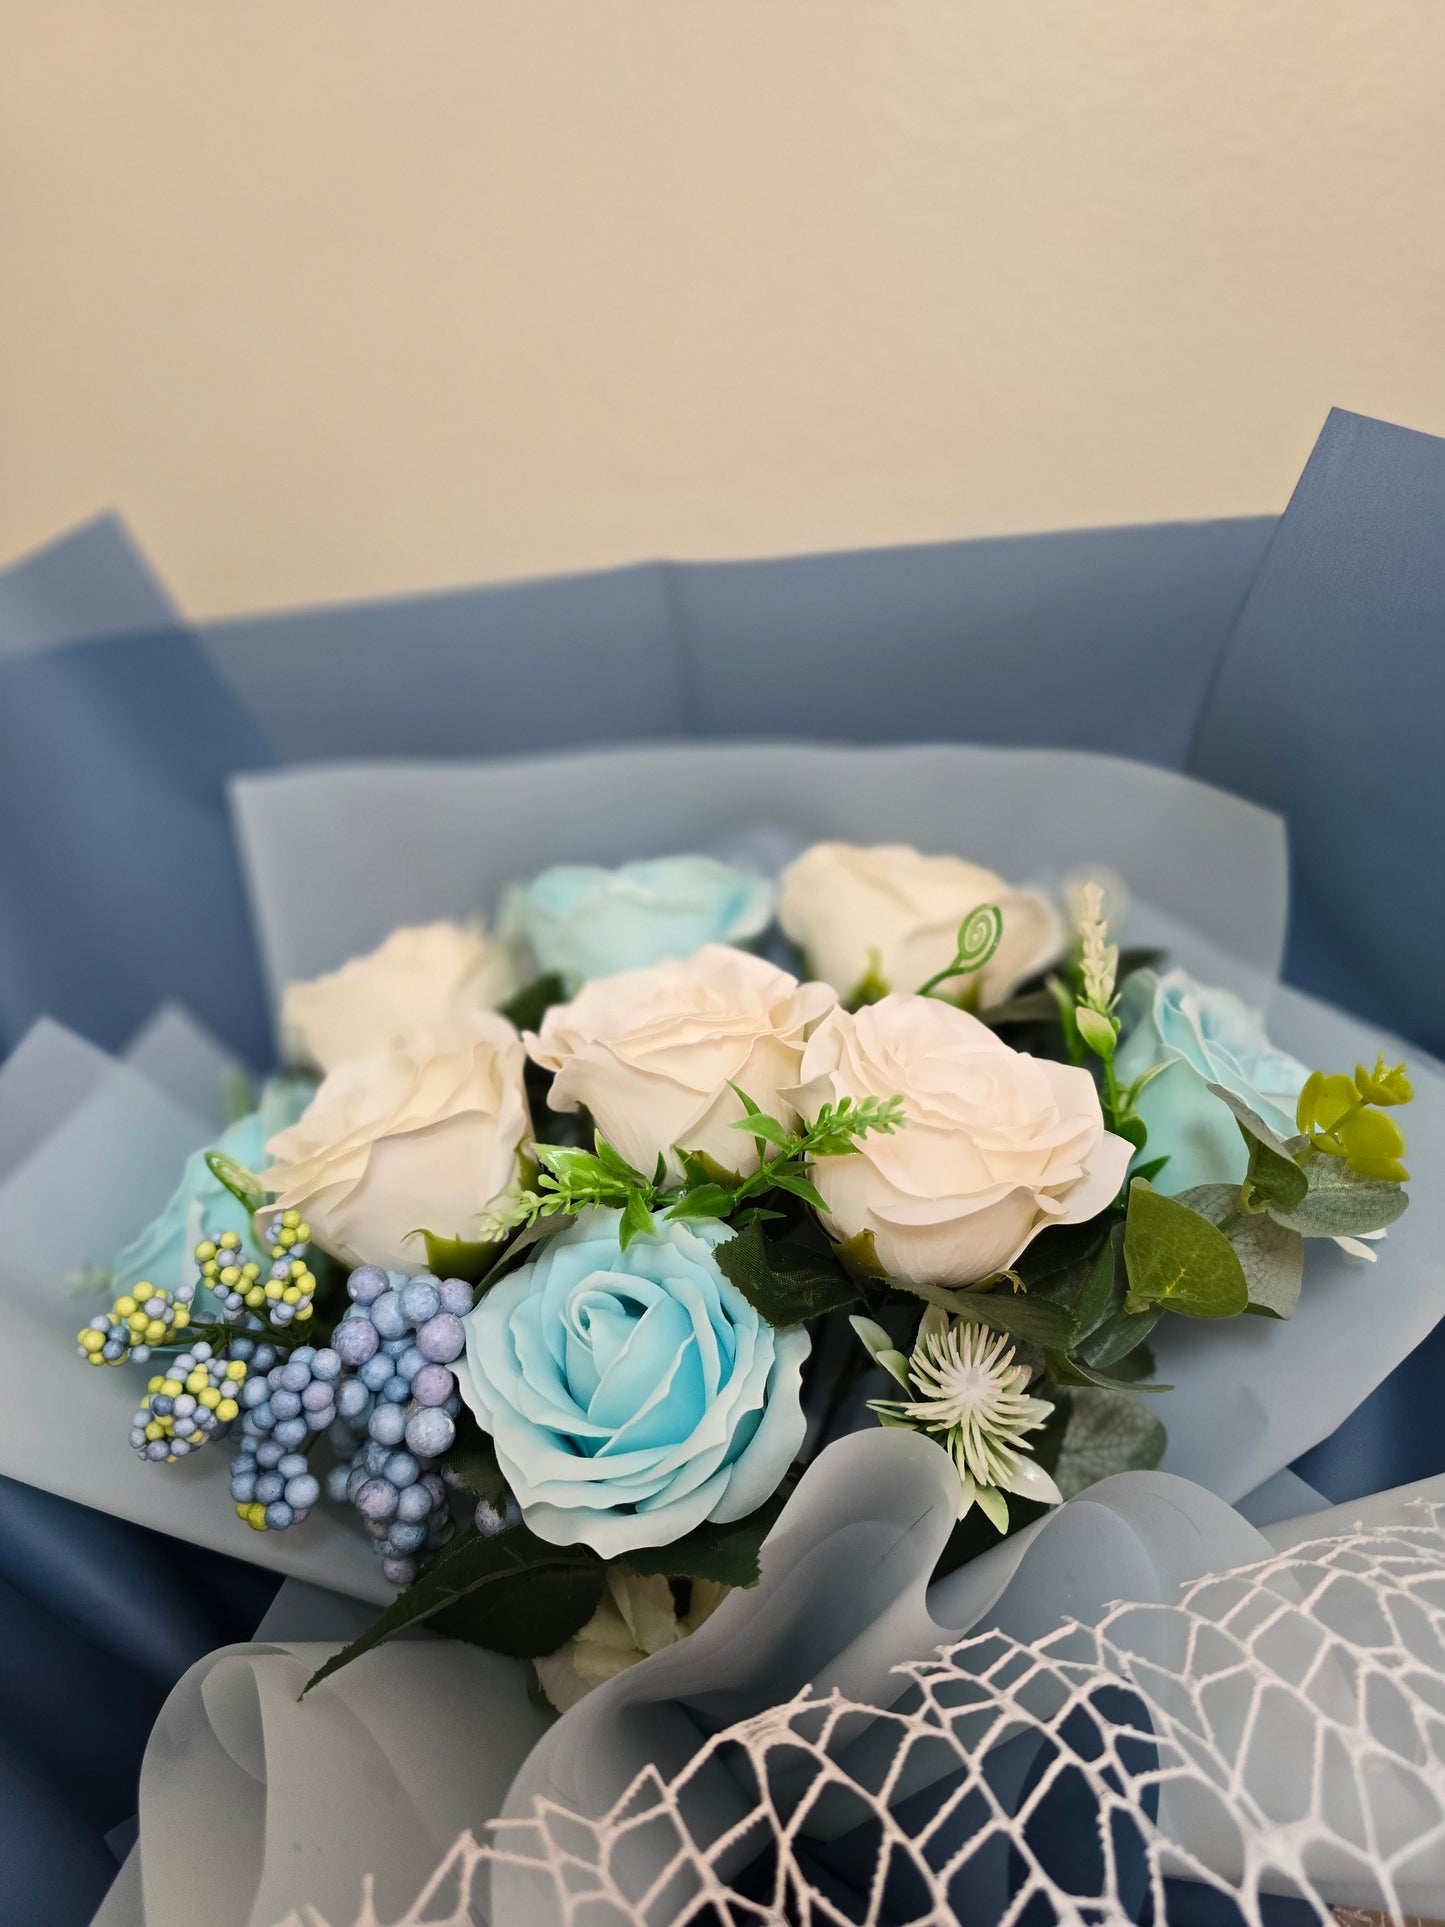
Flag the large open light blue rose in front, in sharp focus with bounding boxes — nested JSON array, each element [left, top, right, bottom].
[[455, 1210, 809, 1559]]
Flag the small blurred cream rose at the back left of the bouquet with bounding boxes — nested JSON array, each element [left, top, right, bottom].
[[279, 923, 516, 1071]]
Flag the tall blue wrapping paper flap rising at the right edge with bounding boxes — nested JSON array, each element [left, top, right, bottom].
[[1191, 409, 1445, 1056]]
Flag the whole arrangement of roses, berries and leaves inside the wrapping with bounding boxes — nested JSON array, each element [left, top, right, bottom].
[[79, 842, 1412, 1709]]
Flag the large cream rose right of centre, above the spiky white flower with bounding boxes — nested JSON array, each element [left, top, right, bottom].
[[792, 996, 1131, 1285]]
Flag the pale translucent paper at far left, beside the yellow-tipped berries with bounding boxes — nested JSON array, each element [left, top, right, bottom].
[[0, 1012, 391, 1603]]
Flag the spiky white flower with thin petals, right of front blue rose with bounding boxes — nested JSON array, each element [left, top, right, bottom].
[[852, 1305, 1064, 1532]]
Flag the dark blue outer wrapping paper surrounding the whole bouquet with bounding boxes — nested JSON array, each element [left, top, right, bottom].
[[0, 402, 1445, 1923]]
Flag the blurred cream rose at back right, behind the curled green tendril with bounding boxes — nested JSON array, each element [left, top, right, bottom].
[[778, 844, 1064, 1010]]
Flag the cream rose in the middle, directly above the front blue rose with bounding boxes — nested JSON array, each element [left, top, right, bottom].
[[526, 944, 836, 1177]]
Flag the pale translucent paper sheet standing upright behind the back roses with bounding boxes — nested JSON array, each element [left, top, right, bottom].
[[231, 742, 1287, 996]]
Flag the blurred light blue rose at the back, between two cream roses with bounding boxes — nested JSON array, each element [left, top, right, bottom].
[[503, 856, 773, 990]]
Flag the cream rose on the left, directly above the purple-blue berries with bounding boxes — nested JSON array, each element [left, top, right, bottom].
[[264, 1010, 532, 1270]]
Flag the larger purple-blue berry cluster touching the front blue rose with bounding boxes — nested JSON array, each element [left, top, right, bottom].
[[328, 1264, 472, 1586]]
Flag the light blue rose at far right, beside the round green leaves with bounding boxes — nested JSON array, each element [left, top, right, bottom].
[[1114, 969, 1308, 1195]]
